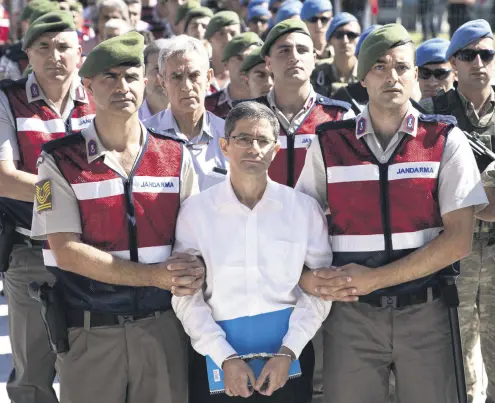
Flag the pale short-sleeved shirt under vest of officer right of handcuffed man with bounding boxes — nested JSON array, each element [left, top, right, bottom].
[[296, 104, 488, 216]]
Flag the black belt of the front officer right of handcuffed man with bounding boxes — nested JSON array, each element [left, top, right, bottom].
[[359, 285, 442, 308]]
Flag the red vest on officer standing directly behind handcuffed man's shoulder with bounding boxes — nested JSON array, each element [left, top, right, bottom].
[[266, 95, 350, 187]]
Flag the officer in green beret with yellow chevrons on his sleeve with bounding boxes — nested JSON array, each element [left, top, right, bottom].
[[32, 32, 204, 403]]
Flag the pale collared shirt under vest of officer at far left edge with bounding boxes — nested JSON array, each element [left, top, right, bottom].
[[0, 73, 88, 161]]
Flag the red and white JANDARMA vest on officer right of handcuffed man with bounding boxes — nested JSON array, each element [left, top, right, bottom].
[[317, 116, 453, 293]]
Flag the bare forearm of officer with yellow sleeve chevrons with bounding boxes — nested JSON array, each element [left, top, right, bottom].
[[48, 235, 158, 287]]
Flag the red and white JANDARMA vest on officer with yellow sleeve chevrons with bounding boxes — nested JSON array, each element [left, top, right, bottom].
[[43, 132, 183, 314]]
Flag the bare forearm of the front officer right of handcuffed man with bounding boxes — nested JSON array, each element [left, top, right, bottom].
[[373, 226, 472, 289]]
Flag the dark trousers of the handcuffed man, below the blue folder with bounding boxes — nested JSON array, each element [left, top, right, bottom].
[[189, 342, 315, 403]]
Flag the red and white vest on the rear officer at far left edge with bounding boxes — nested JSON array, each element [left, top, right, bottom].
[[1, 78, 95, 174]]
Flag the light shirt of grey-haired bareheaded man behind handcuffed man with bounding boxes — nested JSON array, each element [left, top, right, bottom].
[[143, 108, 229, 191]]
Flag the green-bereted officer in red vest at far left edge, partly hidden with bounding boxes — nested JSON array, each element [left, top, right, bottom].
[[0, 11, 94, 403]]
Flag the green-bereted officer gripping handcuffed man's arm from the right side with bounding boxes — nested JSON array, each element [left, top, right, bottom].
[[296, 24, 487, 403]]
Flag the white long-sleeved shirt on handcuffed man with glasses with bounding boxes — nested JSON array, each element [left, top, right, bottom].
[[172, 177, 332, 366]]
